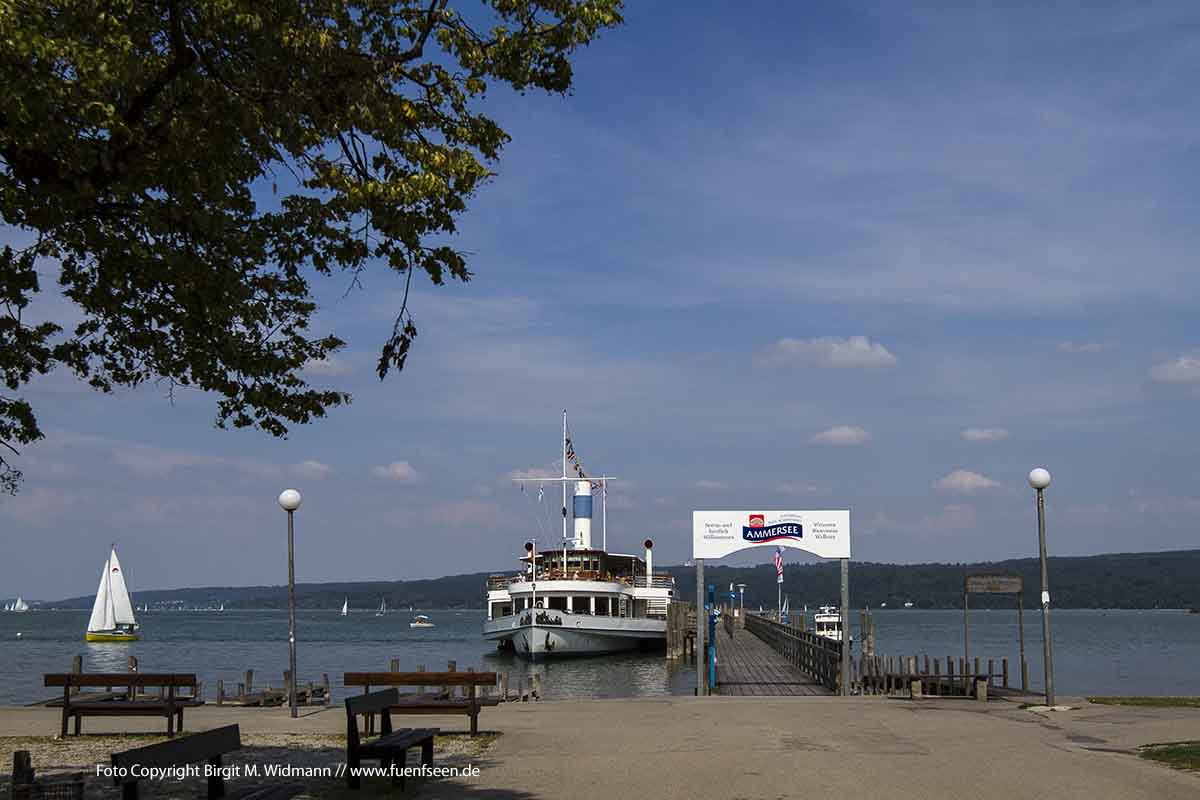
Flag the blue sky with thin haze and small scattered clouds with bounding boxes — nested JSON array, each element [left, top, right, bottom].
[[0, 2, 1200, 599]]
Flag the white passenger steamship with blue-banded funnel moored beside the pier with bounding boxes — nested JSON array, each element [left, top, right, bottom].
[[484, 411, 676, 658]]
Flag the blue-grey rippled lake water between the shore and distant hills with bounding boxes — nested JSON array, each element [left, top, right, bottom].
[[0, 609, 1200, 704]]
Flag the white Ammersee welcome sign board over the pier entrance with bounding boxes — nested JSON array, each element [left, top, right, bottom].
[[691, 510, 850, 559]]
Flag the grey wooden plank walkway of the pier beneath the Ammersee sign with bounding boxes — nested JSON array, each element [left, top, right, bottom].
[[716, 627, 833, 697]]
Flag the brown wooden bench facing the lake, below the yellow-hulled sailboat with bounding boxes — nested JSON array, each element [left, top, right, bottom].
[[46, 672, 204, 736]]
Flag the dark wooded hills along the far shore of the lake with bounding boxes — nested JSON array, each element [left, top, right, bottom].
[[41, 549, 1200, 608]]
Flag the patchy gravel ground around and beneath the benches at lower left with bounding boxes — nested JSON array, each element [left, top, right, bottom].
[[0, 734, 496, 800]]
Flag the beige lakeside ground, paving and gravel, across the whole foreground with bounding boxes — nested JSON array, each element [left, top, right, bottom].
[[0, 697, 1200, 800]]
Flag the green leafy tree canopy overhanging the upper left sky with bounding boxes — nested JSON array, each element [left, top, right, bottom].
[[0, 0, 622, 491]]
